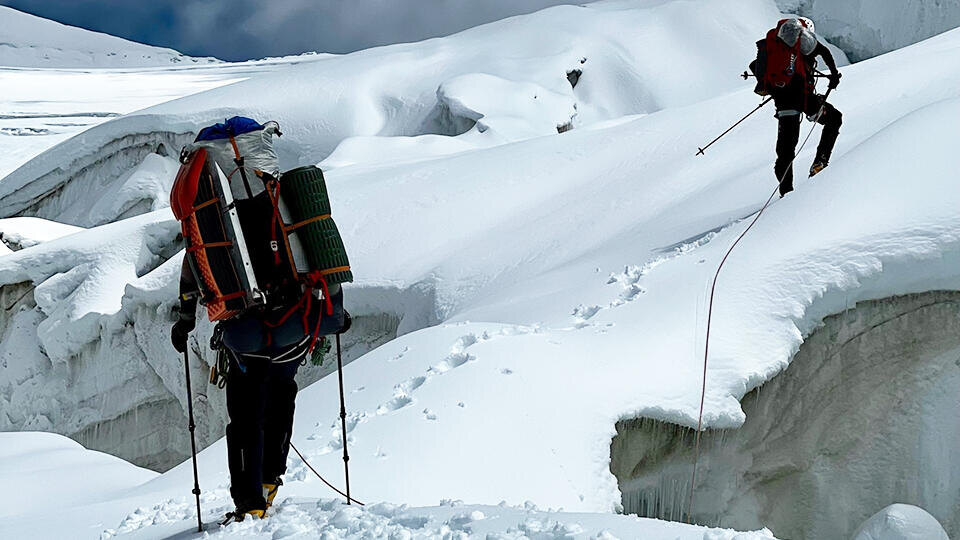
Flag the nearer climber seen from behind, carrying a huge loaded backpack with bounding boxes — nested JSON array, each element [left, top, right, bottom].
[[170, 117, 353, 523]]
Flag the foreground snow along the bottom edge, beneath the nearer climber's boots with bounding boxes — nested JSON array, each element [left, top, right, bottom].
[[0, 433, 776, 540]]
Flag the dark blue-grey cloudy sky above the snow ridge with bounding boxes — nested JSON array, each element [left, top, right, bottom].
[[0, 0, 587, 60]]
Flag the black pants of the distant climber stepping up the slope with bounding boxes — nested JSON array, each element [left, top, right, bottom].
[[773, 95, 843, 196]]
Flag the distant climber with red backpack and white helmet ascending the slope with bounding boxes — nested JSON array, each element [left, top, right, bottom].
[[750, 17, 843, 197]]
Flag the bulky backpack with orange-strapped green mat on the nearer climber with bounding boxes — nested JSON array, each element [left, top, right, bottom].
[[170, 117, 353, 350]]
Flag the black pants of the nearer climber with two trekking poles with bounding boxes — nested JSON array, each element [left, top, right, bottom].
[[227, 359, 300, 511]]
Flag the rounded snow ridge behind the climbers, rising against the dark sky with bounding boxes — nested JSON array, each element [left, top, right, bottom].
[[0, 0, 777, 226]]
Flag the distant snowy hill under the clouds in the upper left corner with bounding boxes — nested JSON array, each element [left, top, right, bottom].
[[0, 6, 218, 68]]
